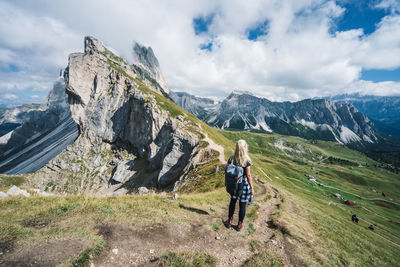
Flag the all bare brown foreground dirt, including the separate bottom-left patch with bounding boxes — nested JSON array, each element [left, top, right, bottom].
[[0, 177, 305, 267]]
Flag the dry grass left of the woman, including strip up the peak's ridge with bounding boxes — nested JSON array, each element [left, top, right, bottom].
[[0, 55, 238, 265]]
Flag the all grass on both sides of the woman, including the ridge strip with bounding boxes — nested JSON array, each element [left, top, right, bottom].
[[0, 49, 400, 266]]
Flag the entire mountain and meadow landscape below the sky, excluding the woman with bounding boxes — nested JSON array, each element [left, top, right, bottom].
[[0, 37, 400, 266]]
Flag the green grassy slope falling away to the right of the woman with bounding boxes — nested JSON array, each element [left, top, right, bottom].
[[222, 132, 400, 266]]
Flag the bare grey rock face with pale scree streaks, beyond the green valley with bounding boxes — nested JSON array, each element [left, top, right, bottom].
[[173, 91, 378, 148]]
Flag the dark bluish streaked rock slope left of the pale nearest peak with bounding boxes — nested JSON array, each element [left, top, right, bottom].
[[0, 78, 78, 174]]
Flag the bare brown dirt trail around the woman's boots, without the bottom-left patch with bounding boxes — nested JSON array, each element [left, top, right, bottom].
[[89, 179, 304, 266]]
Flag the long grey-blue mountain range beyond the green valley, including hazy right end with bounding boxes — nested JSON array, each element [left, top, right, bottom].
[[171, 91, 400, 165]]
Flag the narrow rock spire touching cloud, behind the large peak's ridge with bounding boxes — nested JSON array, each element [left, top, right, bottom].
[[133, 42, 169, 94]]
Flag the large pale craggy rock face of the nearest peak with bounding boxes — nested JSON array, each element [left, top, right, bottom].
[[26, 37, 208, 194]]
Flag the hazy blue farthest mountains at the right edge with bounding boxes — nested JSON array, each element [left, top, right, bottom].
[[326, 93, 400, 140]]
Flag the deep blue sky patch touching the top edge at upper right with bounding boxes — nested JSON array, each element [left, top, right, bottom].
[[336, 1, 390, 34]]
